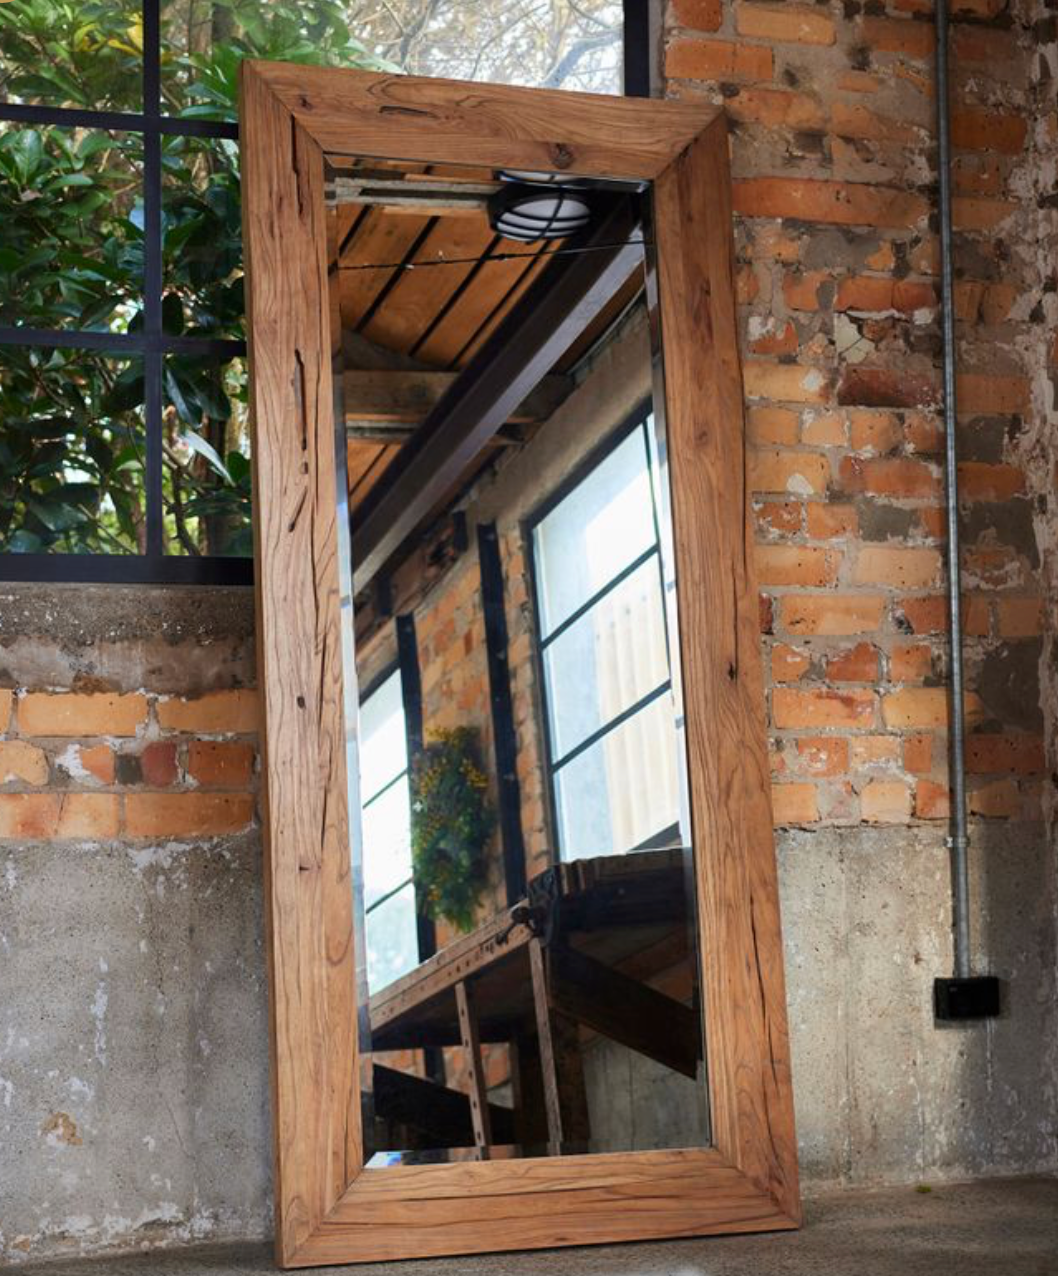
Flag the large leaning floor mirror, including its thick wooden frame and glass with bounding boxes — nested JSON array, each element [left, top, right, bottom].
[[242, 64, 798, 1266]]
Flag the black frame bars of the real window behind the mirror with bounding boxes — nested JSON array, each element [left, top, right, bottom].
[[0, 0, 643, 586]]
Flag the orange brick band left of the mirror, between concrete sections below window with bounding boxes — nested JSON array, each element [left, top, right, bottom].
[[0, 686, 257, 841]]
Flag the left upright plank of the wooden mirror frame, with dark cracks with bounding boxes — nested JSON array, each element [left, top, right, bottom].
[[242, 62, 360, 1261]]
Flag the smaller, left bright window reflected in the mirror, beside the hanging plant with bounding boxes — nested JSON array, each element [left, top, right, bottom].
[[360, 669, 419, 991]]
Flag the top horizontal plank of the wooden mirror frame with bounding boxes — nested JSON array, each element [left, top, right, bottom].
[[249, 61, 719, 180]]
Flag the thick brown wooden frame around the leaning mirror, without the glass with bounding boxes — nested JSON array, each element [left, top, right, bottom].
[[241, 63, 799, 1267]]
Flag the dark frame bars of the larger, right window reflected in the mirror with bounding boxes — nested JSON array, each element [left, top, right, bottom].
[[522, 398, 680, 863]]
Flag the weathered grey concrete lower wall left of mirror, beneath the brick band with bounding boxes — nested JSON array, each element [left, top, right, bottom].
[[0, 835, 271, 1261]]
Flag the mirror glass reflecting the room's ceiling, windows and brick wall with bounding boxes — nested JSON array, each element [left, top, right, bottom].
[[327, 156, 710, 1166]]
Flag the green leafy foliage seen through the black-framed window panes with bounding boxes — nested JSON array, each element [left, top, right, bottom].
[[0, 0, 392, 555]]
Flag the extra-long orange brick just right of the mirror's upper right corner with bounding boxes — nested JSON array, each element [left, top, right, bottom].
[[734, 177, 929, 230]]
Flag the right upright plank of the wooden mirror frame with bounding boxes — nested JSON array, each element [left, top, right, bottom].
[[655, 119, 799, 1217]]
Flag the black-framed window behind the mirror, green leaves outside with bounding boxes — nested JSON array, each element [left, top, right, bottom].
[[0, 0, 648, 583]]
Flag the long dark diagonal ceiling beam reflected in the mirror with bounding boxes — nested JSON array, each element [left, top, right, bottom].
[[351, 195, 643, 593]]
